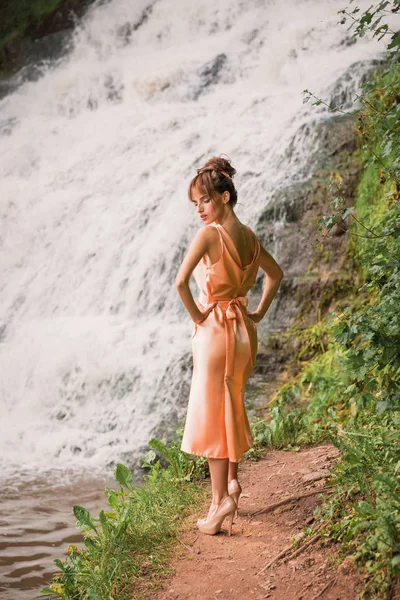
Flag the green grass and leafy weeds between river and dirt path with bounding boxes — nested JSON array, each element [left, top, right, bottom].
[[42, 438, 204, 600]]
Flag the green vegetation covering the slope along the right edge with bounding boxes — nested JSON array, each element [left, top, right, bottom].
[[248, 2, 400, 599]]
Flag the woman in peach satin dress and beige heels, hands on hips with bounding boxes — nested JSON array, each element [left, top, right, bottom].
[[176, 157, 283, 535]]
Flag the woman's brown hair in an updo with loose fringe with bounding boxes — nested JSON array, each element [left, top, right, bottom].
[[188, 156, 237, 208]]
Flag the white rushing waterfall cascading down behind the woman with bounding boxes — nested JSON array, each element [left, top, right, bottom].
[[0, 0, 384, 477]]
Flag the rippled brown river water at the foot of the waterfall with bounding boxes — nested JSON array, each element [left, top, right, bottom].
[[0, 477, 115, 600]]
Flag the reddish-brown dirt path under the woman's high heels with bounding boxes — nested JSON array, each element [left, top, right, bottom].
[[153, 445, 362, 600]]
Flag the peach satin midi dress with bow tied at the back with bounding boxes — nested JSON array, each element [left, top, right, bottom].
[[181, 223, 260, 462]]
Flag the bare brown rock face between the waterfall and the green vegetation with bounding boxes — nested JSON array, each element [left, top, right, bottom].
[[247, 115, 362, 410]]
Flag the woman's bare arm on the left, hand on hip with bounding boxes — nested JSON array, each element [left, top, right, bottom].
[[175, 226, 218, 323]]
